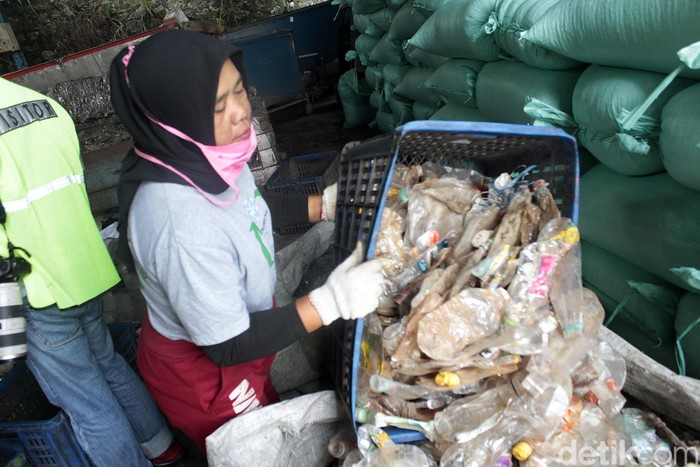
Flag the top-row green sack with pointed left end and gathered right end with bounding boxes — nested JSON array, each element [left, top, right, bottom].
[[408, 0, 500, 62]]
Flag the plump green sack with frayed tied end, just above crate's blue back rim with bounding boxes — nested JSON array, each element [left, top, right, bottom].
[[476, 60, 582, 129]]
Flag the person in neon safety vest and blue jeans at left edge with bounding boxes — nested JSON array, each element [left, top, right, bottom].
[[0, 78, 185, 467]]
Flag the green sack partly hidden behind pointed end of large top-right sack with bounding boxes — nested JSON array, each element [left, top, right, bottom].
[[486, 0, 581, 70]]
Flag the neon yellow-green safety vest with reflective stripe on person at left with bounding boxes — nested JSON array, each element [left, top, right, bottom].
[[0, 78, 119, 308]]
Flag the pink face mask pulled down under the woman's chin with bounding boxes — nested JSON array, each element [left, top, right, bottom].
[[134, 117, 258, 206]]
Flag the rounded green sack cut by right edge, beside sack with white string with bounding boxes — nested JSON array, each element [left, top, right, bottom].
[[659, 83, 700, 191]]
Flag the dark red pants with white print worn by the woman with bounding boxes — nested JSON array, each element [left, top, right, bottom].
[[137, 316, 279, 453]]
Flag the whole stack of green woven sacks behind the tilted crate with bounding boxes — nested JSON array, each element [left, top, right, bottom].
[[334, 0, 700, 378]]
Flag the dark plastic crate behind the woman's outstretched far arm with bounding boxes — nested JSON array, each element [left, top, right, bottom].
[[265, 151, 338, 234]]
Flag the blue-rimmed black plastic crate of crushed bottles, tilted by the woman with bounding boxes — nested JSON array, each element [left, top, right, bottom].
[[331, 120, 579, 442]]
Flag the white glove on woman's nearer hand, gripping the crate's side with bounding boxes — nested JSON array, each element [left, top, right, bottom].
[[309, 242, 384, 325]]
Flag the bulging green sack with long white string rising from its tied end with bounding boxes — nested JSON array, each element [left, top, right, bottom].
[[573, 65, 692, 175]]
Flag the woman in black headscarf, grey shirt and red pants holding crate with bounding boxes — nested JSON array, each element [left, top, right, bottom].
[[110, 30, 383, 452]]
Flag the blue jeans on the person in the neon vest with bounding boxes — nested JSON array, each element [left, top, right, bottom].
[[26, 297, 173, 467]]
